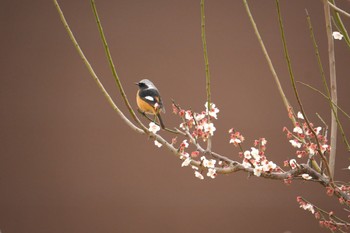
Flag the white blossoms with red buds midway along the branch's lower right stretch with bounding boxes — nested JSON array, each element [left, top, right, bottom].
[[242, 138, 280, 176]]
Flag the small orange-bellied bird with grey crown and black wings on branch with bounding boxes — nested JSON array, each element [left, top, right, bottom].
[[135, 79, 165, 129]]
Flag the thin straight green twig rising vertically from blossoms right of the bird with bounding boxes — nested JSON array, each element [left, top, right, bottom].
[[201, 0, 211, 151]]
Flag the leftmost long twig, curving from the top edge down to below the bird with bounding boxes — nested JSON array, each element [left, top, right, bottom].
[[53, 0, 144, 133]]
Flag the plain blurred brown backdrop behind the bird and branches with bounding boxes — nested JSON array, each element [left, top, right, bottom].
[[0, 0, 350, 233]]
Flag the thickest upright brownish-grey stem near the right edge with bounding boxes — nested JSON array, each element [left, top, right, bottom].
[[323, 0, 338, 177]]
